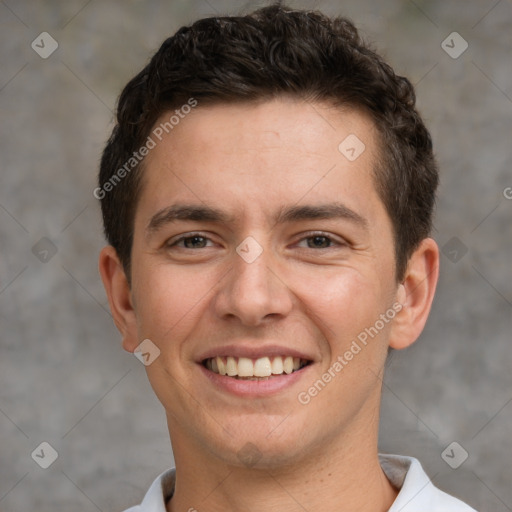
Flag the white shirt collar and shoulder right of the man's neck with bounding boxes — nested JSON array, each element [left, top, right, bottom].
[[379, 454, 476, 512]]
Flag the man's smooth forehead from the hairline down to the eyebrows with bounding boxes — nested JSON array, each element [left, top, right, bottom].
[[138, 97, 384, 228]]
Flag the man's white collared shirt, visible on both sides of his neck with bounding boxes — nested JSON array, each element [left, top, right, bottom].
[[125, 454, 476, 512]]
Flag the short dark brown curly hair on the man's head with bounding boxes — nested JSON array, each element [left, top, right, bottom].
[[98, 4, 439, 281]]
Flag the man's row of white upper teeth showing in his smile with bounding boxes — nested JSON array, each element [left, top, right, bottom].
[[206, 356, 307, 377]]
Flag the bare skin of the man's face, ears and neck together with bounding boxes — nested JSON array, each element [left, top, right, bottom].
[[100, 97, 439, 512]]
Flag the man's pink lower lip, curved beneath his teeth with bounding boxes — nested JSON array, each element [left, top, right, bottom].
[[198, 364, 312, 398]]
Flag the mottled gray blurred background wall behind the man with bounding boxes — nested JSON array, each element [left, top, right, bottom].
[[0, 0, 512, 512]]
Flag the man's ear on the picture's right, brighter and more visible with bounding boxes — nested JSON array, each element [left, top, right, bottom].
[[389, 238, 439, 350]]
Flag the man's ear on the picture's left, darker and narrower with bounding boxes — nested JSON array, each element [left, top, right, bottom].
[[99, 245, 138, 352]]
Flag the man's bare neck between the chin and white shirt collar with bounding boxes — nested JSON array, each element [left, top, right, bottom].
[[168, 412, 397, 512]]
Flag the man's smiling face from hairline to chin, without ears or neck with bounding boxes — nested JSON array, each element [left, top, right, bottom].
[[125, 99, 398, 464]]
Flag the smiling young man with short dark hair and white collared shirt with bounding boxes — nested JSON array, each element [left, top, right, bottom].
[[95, 5, 473, 512]]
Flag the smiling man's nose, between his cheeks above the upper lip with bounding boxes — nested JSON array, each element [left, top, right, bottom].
[[215, 239, 293, 327]]
